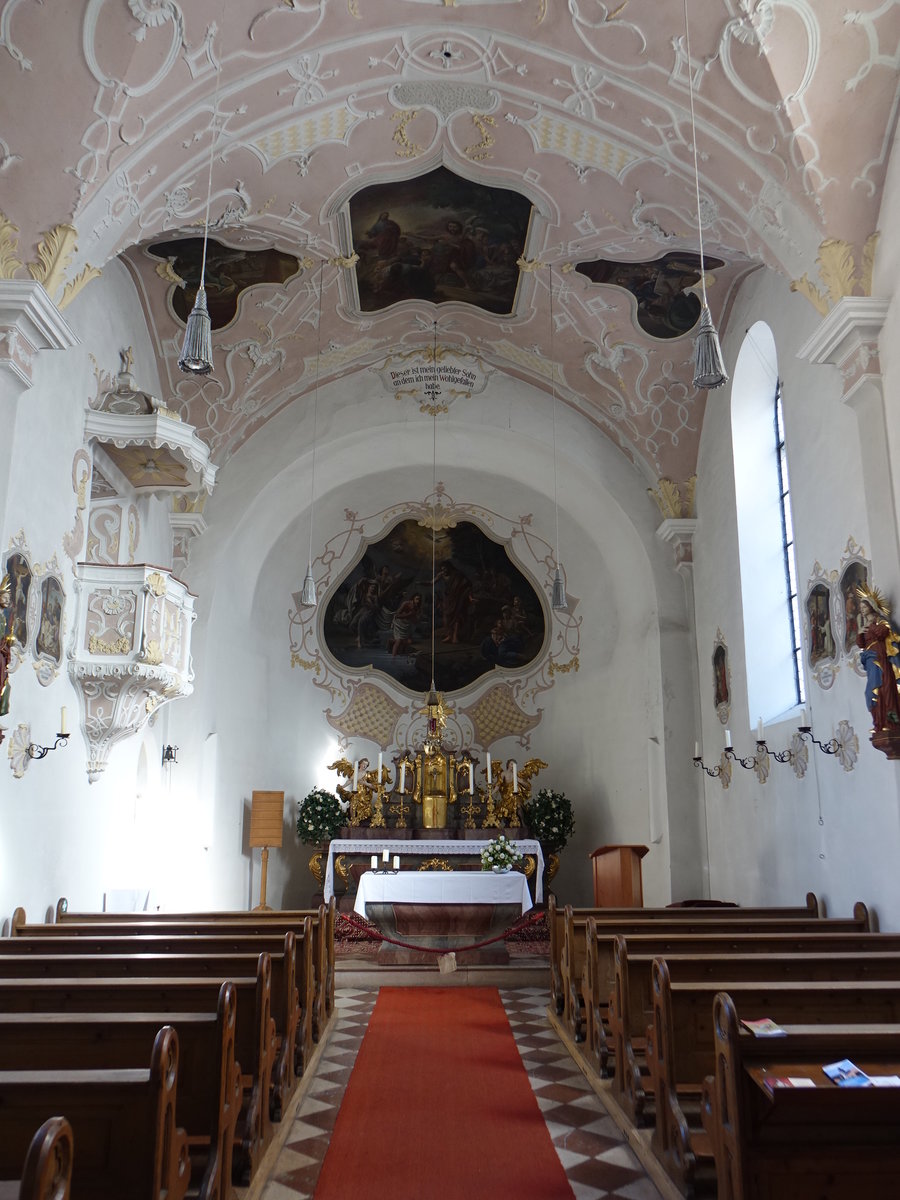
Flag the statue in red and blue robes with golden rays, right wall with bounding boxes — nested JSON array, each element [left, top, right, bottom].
[[857, 586, 900, 758]]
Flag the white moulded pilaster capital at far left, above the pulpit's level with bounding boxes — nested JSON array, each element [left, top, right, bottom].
[[0, 280, 78, 391]]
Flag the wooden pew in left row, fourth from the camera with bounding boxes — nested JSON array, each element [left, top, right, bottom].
[[0, 954, 275, 1182]]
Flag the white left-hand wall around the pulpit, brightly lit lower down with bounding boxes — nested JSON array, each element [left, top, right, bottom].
[[0, 263, 202, 926]]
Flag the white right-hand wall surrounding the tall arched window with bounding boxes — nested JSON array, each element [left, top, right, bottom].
[[694, 272, 900, 929]]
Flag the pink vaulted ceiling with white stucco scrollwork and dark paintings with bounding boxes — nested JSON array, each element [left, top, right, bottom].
[[0, 0, 900, 481]]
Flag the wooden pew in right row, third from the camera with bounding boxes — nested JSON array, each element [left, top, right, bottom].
[[610, 937, 900, 1124]]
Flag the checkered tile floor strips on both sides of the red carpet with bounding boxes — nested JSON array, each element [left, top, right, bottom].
[[262, 988, 659, 1200]]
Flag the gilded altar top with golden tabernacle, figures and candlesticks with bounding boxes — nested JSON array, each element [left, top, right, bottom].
[[329, 688, 547, 838]]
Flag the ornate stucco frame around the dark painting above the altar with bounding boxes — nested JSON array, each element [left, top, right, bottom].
[[288, 482, 582, 748]]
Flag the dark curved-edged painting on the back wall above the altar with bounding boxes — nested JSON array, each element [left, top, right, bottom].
[[323, 521, 545, 692]]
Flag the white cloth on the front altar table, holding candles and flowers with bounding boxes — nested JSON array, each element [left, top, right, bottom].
[[353, 871, 532, 917]]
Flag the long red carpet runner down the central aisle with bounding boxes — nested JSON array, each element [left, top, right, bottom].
[[316, 988, 572, 1200]]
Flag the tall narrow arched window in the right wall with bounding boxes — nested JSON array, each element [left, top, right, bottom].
[[731, 320, 804, 721]]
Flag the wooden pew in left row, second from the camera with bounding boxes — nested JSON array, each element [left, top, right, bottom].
[[0, 1026, 191, 1200]]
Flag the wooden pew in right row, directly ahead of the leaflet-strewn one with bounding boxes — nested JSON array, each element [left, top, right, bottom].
[[647, 959, 900, 1195]]
